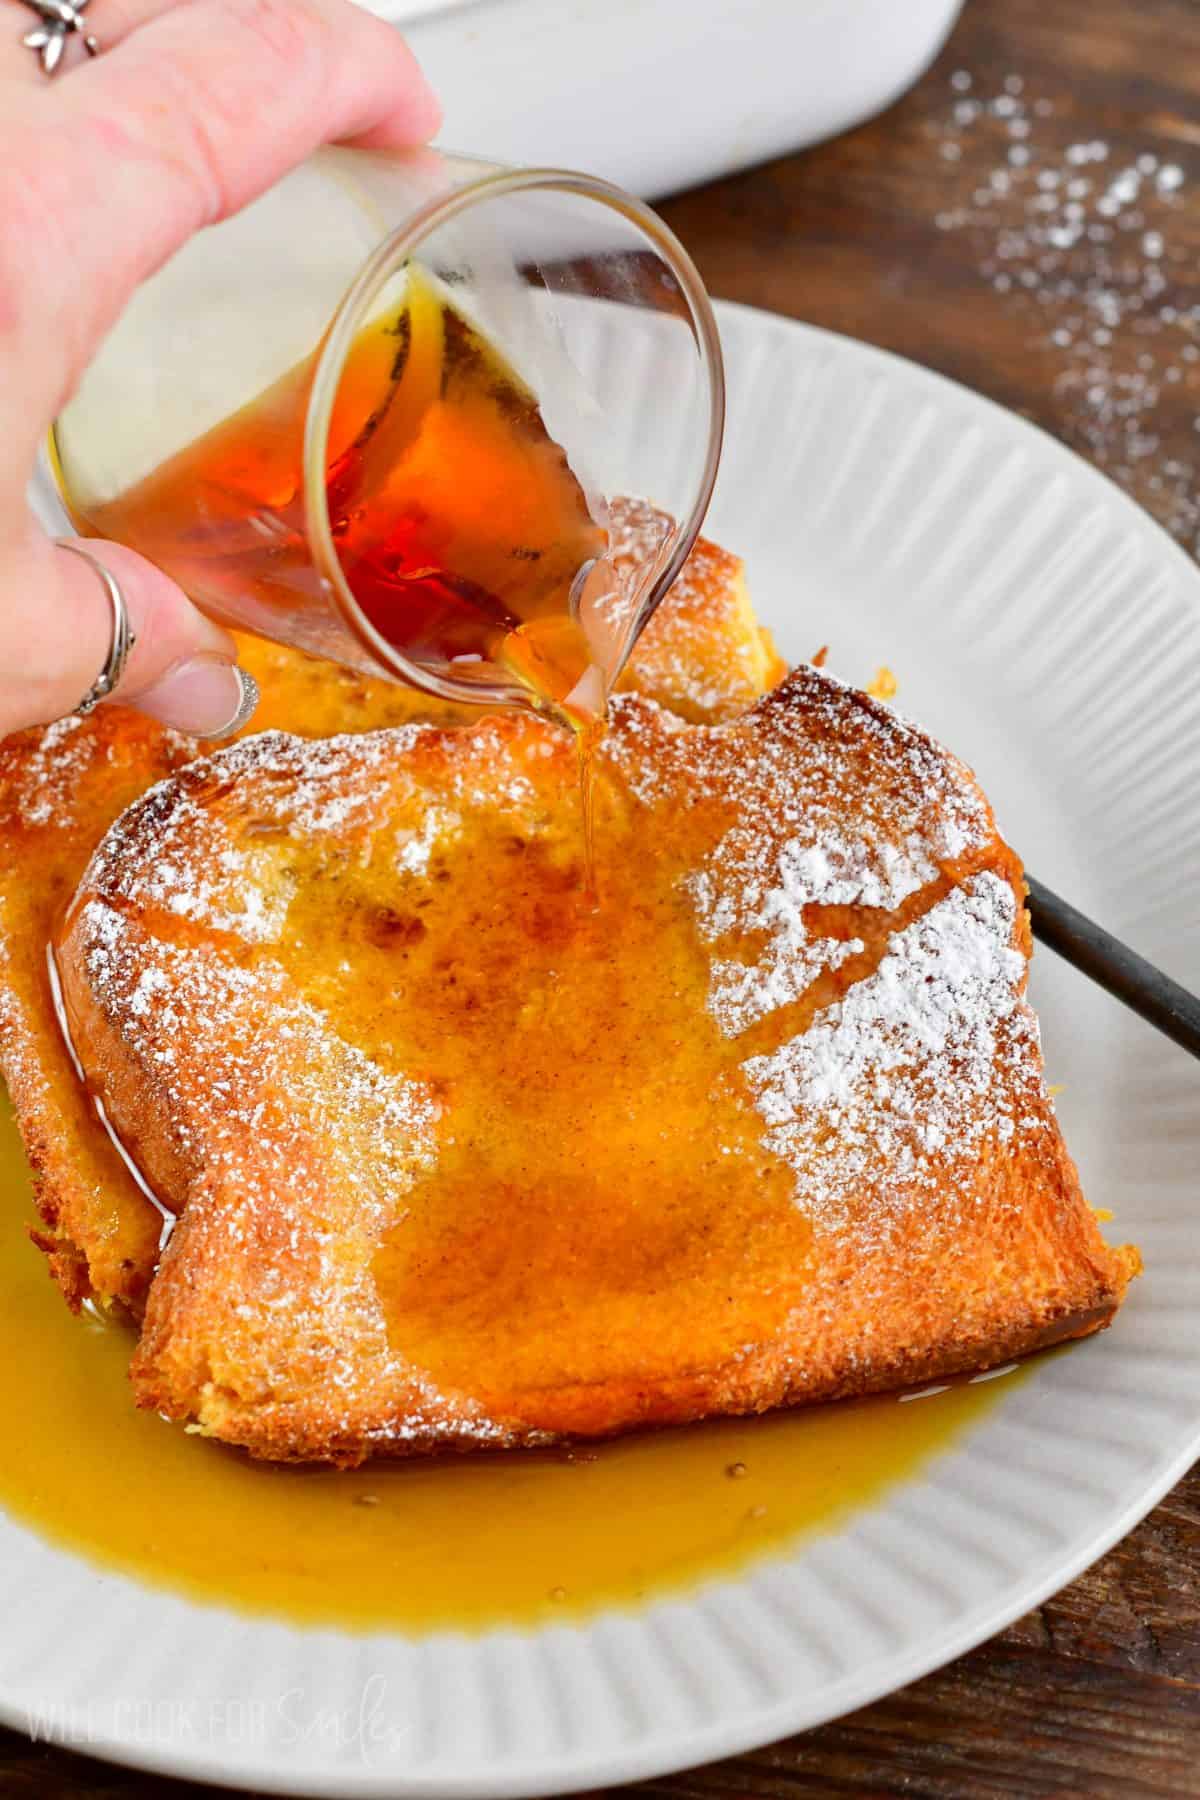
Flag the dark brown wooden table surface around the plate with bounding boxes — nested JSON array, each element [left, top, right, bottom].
[[0, 0, 1200, 1800]]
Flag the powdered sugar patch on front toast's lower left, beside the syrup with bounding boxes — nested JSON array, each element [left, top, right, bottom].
[[81, 900, 474, 1442]]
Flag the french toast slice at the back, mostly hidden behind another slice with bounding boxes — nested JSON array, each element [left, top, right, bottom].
[[0, 514, 783, 1314]]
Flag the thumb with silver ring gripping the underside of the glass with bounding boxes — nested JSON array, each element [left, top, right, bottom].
[[0, 526, 257, 738]]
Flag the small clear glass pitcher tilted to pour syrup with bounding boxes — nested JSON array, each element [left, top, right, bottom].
[[50, 148, 725, 720]]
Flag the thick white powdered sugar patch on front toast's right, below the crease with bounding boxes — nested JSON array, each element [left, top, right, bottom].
[[743, 873, 1042, 1235]]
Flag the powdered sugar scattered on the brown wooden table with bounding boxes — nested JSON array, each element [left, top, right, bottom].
[[930, 68, 1200, 551]]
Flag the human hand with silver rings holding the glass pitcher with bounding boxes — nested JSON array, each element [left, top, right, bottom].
[[0, 0, 439, 736]]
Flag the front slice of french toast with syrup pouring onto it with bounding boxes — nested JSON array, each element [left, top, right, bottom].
[[56, 668, 1137, 1463]]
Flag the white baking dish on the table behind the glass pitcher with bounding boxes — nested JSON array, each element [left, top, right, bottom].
[[365, 0, 963, 196]]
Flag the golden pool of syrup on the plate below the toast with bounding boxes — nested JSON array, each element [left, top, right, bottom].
[[0, 1096, 1016, 1631]]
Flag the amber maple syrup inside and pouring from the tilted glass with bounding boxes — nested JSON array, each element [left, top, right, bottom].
[[76, 268, 635, 871]]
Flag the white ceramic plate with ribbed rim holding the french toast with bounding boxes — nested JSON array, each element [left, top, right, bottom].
[[9, 308, 1200, 1796]]
